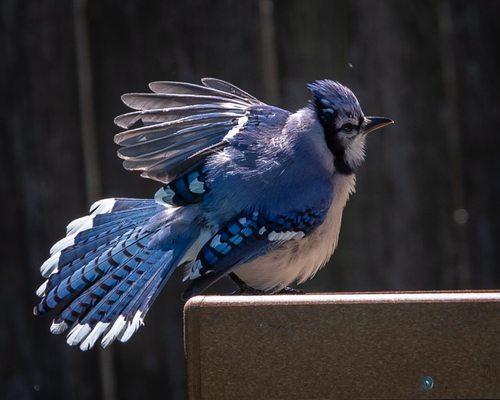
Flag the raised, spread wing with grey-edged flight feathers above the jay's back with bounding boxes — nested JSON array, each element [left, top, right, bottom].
[[111, 78, 289, 183]]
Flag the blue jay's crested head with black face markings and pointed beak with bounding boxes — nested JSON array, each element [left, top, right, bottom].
[[307, 79, 394, 174]]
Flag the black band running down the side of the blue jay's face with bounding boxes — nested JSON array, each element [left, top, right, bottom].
[[314, 98, 354, 175]]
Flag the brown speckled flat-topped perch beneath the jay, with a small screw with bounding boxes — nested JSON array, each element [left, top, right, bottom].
[[185, 292, 500, 400]]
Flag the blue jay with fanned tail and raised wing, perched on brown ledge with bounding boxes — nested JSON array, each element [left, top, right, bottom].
[[34, 78, 393, 350]]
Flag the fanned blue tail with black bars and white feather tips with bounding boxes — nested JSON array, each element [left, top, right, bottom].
[[34, 199, 197, 350]]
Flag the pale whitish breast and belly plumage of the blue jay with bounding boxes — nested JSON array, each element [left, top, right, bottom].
[[235, 174, 355, 291]]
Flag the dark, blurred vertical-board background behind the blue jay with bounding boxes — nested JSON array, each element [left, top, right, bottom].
[[0, 0, 500, 400]]
